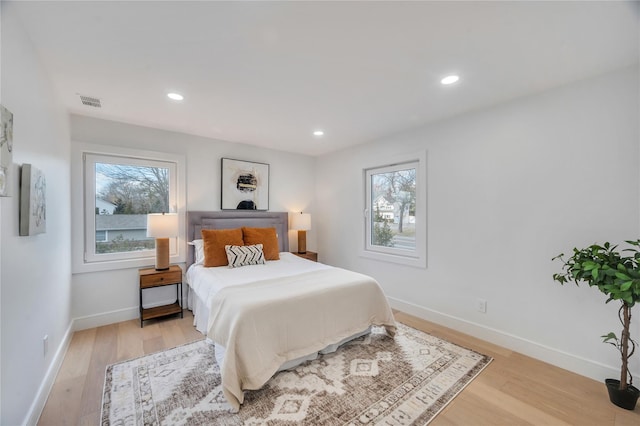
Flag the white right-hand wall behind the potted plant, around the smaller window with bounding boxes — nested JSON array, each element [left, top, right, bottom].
[[316, 67, 640, 379]]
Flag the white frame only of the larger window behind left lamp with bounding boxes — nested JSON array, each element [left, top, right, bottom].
[[71, 143, 186, 273]]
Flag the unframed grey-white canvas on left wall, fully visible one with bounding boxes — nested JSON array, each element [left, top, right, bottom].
[[19, 163, 47, 236]]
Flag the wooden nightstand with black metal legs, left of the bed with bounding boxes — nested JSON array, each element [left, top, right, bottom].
[[138, 265, 184, 327]]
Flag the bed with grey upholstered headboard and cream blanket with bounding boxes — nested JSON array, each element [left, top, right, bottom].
[[186, 211, 395, 410]]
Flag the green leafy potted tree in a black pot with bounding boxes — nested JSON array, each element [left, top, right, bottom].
[[553, 239, 640, 410]]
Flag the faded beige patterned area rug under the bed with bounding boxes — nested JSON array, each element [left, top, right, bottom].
[[102, 324, 491, 426]]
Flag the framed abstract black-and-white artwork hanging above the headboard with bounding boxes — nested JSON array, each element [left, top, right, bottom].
[[221, 158, 269, 211]]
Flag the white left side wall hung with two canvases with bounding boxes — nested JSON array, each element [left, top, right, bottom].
[[0, 2, 71, 425]]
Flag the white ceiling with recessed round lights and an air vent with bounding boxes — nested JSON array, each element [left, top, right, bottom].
[[7, 1, 640, 155]]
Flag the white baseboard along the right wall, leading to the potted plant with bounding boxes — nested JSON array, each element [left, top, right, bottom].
[[388, 297, 637, 381]]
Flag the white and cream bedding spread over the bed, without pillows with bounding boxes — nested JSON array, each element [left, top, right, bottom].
[[188, 253, 395, 410]]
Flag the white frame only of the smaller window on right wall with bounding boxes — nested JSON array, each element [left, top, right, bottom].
[[360, 152, 427, 268]]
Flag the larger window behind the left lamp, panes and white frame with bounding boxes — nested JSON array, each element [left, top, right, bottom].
[[72, 144, 184, 272]]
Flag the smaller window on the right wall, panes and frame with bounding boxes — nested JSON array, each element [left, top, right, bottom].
[[363, 153, 426, 267]]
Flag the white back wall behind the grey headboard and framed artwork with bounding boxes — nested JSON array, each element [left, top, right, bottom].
[[71, 115, 316, 328]]
